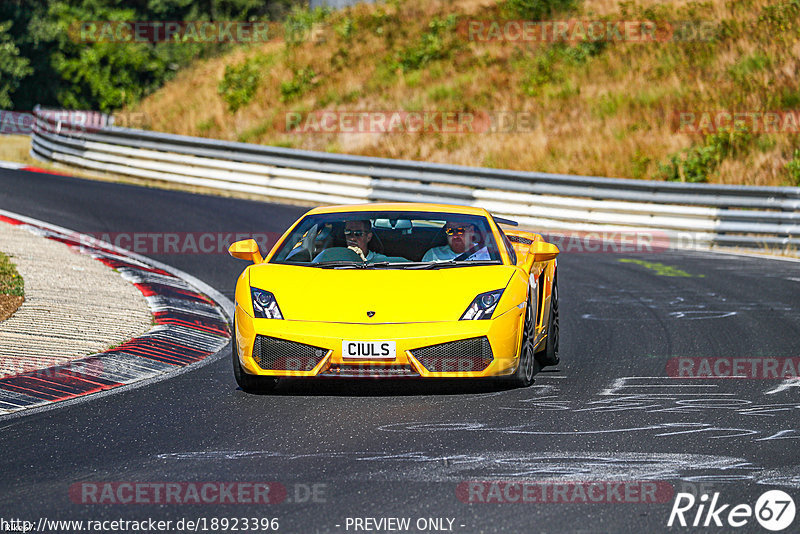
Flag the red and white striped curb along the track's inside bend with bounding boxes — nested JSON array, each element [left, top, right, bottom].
[[0, 209, 233, 418]]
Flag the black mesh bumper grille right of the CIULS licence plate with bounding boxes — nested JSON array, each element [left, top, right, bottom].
[[411, 336, 494, 373]]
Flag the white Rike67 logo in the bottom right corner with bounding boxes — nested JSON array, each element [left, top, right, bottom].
[[667, 490, 795, 532]]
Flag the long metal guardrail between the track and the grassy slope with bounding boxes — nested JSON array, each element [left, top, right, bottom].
[[31, 108, 800, 252]]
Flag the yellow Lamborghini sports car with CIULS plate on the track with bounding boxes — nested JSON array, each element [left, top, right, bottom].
[[229, 203, 559, 391]]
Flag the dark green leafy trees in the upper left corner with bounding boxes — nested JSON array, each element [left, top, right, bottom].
[[0, 0, 303, 111]]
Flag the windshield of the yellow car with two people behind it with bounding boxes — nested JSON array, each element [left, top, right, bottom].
[[270, 211, 502, 269]]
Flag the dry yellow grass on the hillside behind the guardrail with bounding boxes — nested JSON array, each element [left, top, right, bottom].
[[125, 0, 800, 185]]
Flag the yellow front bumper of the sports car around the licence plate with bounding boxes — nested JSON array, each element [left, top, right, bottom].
[[234, 306, 525, 378]]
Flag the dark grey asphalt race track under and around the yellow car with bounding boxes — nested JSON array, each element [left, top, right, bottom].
[[0, 165, 800, 533]]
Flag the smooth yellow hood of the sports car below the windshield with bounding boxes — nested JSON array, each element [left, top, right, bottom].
[[250, 264, 519, 324]]
